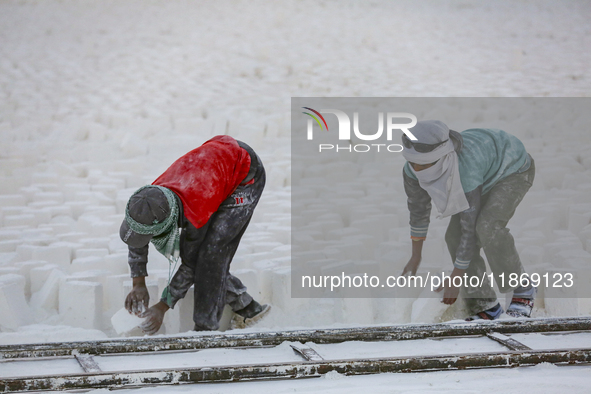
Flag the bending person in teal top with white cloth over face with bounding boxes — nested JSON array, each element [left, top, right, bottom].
[[402, 120, 536, 320]]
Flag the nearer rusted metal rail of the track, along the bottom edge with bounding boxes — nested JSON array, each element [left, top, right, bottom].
[[0, 349, 591, 393]]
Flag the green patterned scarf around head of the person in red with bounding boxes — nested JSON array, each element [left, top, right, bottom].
[[125, 185, 180, 263]]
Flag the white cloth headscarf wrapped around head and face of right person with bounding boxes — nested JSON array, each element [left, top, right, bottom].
[[402, 120, 470, 219]]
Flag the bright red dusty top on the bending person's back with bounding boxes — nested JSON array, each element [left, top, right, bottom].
[[152, 135, 250, 228]]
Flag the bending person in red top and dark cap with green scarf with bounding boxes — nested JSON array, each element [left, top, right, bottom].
[[120, 136, 270, 335]]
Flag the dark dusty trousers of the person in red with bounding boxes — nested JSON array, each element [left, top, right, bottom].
[[164, 146, 266, 330]]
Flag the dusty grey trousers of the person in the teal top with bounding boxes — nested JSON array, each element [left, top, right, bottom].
[[445, 159, 535, 314]]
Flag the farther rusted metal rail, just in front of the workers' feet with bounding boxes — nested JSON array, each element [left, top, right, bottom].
[[0, 317, 591, 358]]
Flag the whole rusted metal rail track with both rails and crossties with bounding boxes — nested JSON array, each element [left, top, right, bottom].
[[0, 317, 591, 393]]
